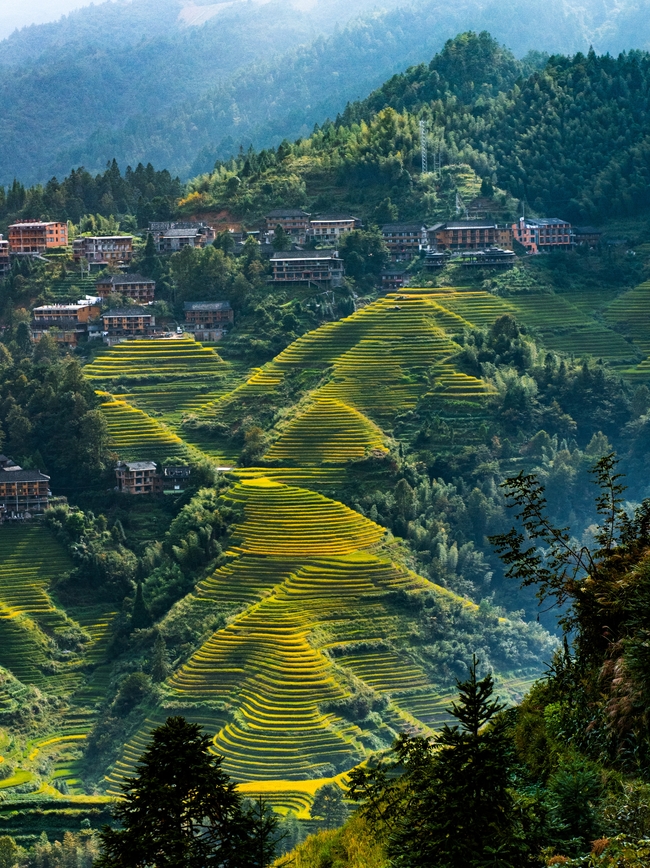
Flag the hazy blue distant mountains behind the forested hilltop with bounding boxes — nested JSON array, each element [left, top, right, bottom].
[[0, 0, 650, 184]]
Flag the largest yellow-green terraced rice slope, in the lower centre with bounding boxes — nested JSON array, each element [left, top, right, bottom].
[[109, 479, 470, 791]]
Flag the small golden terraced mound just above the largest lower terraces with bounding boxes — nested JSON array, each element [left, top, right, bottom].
[[265, 398, 386, 465]]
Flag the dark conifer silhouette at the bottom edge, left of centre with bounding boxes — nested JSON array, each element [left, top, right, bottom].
[[96, 717, 277, 868]]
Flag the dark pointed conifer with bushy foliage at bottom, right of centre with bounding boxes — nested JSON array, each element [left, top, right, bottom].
[[350, 657, 522, 868]]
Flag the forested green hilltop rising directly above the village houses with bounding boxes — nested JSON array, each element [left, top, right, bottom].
[[183, 33, 650, 222]]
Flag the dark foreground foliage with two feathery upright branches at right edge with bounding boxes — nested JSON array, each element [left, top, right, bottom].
[[491, 454, 650, 777]]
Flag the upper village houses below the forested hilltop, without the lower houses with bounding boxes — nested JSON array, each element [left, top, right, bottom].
[[8, 208, 599, 346]]
